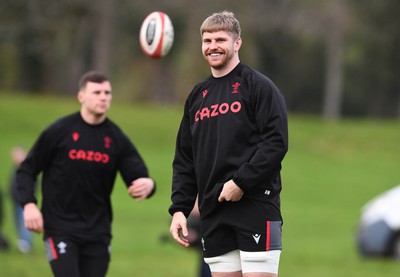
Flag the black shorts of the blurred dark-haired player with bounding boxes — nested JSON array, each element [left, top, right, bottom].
[[44, 236, 110, 277]]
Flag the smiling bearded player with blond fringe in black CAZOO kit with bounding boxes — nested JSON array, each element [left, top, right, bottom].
[[169, 11, 288, 277]]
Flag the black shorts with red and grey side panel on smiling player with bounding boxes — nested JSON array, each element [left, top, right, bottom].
[[201, 198, 282, 258]]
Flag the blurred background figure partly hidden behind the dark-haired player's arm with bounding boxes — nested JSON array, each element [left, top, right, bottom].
[[10, 146, 32, 254]]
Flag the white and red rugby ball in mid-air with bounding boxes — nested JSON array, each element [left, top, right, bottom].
[[140, 11, 174, 59]]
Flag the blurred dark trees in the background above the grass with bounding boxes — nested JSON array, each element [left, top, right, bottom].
[[0, 0, 400, 119]]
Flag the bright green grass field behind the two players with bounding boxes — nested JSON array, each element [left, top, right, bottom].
[[0, 94, 400, 277]]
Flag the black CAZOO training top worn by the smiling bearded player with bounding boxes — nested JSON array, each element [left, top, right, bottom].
[[169, 63, 288, 220]]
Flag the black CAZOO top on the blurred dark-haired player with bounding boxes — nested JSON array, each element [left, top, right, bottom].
[[17, 112, 154, 238]]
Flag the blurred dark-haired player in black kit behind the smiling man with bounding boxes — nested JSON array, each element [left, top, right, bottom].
[[17, 72, 155, 277]]
